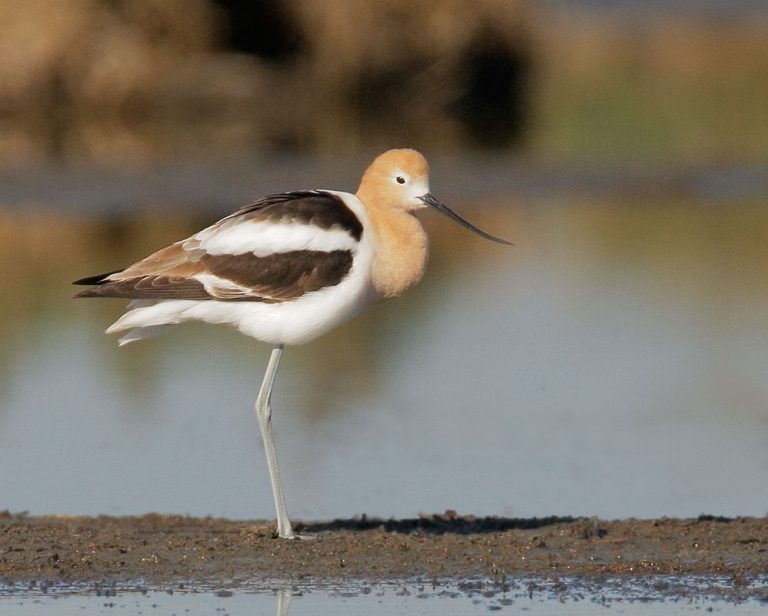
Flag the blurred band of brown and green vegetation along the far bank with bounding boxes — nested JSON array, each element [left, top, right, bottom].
[[0, 0, 768, 165]]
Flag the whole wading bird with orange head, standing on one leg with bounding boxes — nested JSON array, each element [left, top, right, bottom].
[[74, 149, 509, 538]]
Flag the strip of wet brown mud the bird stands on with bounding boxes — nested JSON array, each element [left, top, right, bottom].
[[0, 512, 768, 600]]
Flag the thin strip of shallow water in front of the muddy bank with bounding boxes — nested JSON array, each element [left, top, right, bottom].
[[0, 577, 765, 616]]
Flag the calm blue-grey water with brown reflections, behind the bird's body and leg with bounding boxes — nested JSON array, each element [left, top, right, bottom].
[[0, 168, 768, 519]]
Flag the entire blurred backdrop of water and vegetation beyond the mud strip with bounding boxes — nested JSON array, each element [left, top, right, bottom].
[[0, 0, 768, 519]]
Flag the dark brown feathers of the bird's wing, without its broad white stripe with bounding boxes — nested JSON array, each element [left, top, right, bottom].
[[75, 192, 362, 302]]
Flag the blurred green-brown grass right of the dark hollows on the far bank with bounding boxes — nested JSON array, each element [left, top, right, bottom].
[[532, 15, 768, 162]]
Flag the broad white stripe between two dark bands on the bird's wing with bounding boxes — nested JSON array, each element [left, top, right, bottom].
[[194, 221, 357, 257]]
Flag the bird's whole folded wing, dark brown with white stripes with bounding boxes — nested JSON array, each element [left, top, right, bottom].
[[75, 190, 363, 303]]
